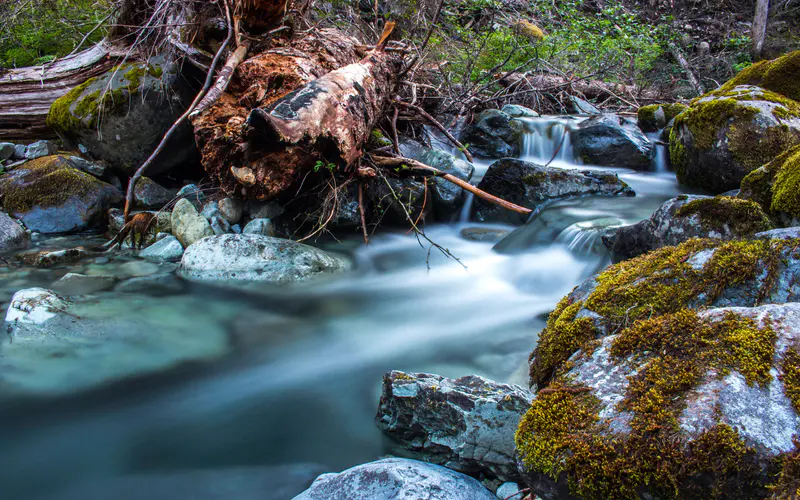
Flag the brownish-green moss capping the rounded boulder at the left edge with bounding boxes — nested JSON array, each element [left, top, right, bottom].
[[0, 155, 101, 213]]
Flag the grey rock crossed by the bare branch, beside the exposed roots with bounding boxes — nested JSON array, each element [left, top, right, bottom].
[[400, 138, 475, 222]]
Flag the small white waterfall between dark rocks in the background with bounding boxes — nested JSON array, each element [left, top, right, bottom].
[[520, 116, 582, 165]]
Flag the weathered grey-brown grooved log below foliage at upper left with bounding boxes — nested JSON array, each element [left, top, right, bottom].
[[0, 42, 124, 140]]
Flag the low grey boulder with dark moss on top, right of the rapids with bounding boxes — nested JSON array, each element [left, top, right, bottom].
[[603, 195, 772, 261]]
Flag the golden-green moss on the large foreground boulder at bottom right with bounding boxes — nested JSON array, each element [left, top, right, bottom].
[[515, 309, 776, 499]]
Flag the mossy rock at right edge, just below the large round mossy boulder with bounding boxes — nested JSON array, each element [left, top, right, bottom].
[[739, 145, 800, 226]]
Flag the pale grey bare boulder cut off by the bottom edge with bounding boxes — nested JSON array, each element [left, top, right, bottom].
[[294, 458, 497, 500]]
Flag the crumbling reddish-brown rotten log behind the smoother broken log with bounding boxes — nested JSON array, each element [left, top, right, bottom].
[[190, 29, 380, 199]]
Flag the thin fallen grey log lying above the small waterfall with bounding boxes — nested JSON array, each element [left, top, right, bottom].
[[498, 73, 661, 99]]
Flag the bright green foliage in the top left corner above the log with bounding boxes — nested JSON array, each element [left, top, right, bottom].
[[0, 0, 111, 68]]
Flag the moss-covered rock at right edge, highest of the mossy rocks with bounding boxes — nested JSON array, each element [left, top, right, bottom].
[[719, 50, 800, 101]]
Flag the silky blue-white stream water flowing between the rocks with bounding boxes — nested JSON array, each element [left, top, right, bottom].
[[0, 118, 678, 498]]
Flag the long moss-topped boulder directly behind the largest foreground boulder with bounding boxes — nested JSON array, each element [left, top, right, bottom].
[[530, 239, 800, 387]]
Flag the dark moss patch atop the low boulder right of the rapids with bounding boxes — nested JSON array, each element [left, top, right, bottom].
[[675, 196, 773, 237]]
